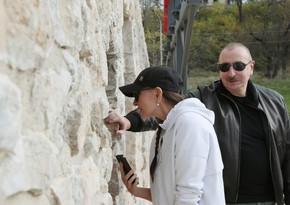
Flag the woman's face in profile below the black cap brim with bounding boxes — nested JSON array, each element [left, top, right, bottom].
[[133, 88, 158, 119]]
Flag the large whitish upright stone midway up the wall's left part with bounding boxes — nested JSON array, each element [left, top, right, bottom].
[[29, 69, 72, 130]]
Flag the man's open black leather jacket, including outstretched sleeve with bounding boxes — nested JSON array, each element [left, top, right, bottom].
[[126, 81, 290, 205]]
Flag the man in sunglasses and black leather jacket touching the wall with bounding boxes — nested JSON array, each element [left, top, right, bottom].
[[106, 43, 290, 205]]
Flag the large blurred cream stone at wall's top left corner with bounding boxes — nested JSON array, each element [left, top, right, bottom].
[[3, 0, 54, 71]]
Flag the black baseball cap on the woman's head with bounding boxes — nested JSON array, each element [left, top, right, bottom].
[[119, 66, 183, 97]]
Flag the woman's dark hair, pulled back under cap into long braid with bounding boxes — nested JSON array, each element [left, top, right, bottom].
[[150, 91, 184, 181]]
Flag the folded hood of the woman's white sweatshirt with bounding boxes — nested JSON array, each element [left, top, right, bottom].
[[160, 98, 215, 130]]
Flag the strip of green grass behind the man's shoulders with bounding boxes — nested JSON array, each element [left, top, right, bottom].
[[187, 71, 290, 112]]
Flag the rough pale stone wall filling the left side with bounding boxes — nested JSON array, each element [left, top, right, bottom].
[[0, 0, 152, 205]]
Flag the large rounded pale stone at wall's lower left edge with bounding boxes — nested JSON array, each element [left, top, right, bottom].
[[0, 132, 58, 197]]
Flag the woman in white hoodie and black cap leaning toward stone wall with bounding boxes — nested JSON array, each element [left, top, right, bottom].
[[116, 66, 225, 205]]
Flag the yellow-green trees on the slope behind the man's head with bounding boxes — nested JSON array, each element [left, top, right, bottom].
[[189, 0, 290, 78]]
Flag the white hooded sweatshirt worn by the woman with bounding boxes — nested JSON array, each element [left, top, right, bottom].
[[150, 98, 225, 205]]
